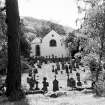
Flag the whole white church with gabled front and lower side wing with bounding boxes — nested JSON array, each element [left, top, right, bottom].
[[30, 30, 69, 58]]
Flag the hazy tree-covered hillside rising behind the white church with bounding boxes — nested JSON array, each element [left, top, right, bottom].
[[22, 17, 73, 40]]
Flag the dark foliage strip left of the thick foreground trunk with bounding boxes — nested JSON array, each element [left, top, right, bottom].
[[0, 8, 8, 72]]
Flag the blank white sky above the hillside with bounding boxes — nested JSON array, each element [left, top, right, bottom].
[[18, 0, 78, 28]]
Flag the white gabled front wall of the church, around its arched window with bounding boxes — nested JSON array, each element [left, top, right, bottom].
[[41, 31, 68, 57]]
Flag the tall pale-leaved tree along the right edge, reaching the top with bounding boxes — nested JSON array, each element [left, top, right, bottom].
[[76, 0, 105, 95]]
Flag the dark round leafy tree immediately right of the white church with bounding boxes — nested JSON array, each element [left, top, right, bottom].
[[66, 32, 88, 57]]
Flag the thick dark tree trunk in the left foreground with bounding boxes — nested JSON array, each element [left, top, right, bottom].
[[6, 0, 23, 101]]
